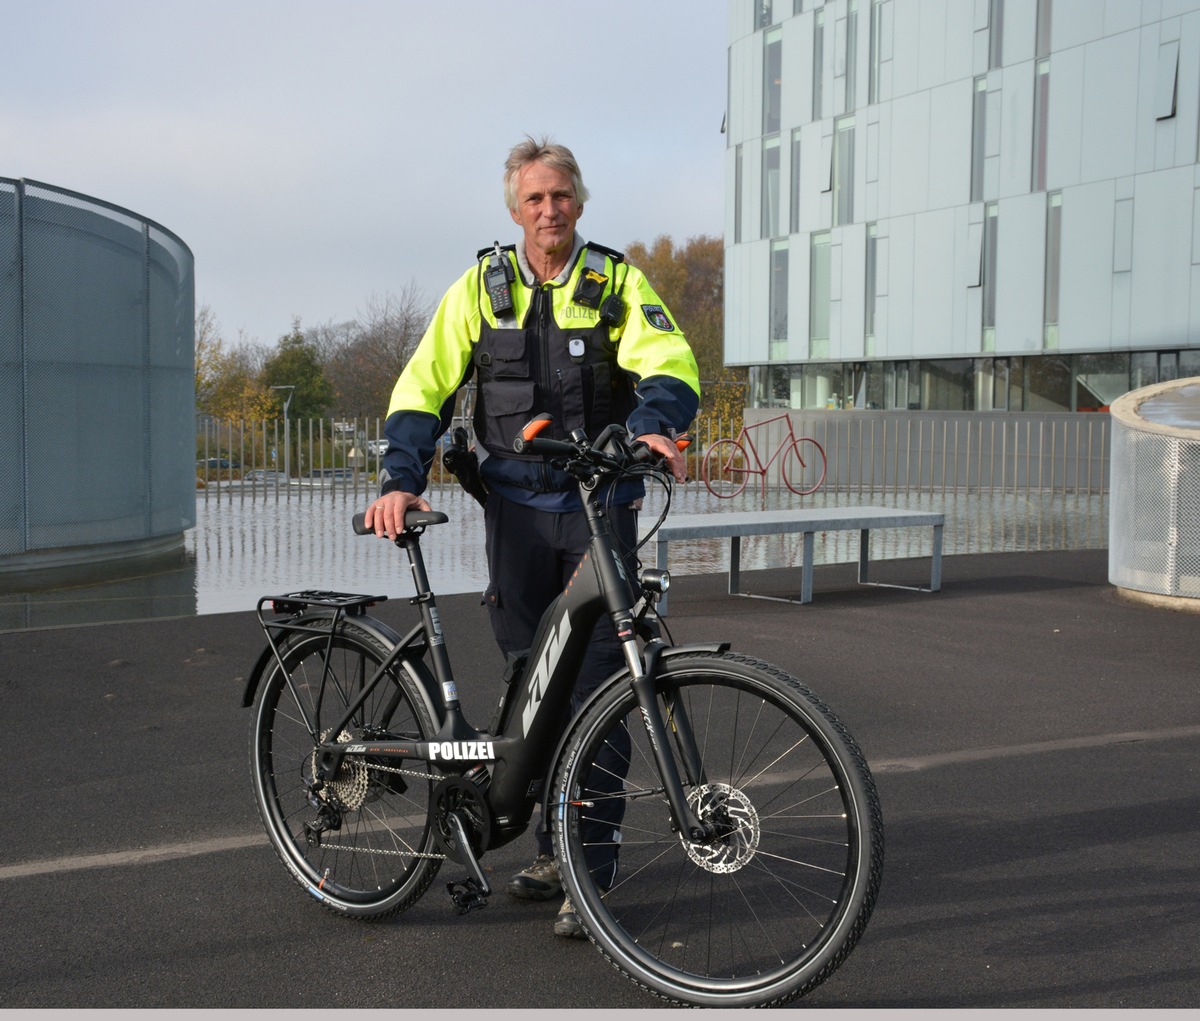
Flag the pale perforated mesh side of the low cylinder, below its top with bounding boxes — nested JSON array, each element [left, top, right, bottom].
[[1109, 393, 1200, 597]]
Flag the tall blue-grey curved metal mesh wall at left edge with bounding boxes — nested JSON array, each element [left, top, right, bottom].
[[0, 179, 196, 559]]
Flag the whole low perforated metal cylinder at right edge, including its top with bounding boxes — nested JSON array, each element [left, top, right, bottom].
[[1109, 378, 1200, 609]]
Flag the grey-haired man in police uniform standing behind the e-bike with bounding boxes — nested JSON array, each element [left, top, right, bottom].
[[366, 138, 700, 936]]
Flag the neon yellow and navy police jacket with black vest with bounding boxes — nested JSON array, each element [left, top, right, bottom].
[[382, 235, 700, 510]]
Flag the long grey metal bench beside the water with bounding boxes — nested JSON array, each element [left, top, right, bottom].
[[655, 506, 946, 615]]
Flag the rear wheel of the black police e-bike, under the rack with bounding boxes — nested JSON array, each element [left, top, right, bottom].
[[251, 619, 442, 918]]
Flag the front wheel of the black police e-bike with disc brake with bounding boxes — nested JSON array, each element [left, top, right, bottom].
[[553, 651, 883, 1007]]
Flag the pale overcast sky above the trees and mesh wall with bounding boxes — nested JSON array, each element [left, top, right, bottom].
[[0, 0, 727, 346]]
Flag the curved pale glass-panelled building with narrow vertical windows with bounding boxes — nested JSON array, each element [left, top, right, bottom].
[[725, 0, 1200, 412]]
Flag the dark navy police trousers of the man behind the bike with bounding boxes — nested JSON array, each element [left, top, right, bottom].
[[484, 492, 637, 889]]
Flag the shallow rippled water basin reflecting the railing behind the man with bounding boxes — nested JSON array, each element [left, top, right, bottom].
[[0, 484, 1108, 630]]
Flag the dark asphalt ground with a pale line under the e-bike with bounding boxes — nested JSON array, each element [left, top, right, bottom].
[[0, 551, 1200, 1009]]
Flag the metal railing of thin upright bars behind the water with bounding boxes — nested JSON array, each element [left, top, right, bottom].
[[196, 408, 1111, 500]]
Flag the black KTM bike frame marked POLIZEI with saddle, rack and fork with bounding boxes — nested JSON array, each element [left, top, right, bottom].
[[244, 470, 725, 863]]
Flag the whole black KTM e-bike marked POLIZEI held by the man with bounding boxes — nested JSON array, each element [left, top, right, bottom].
[[244, 416, 883, 1007]]
